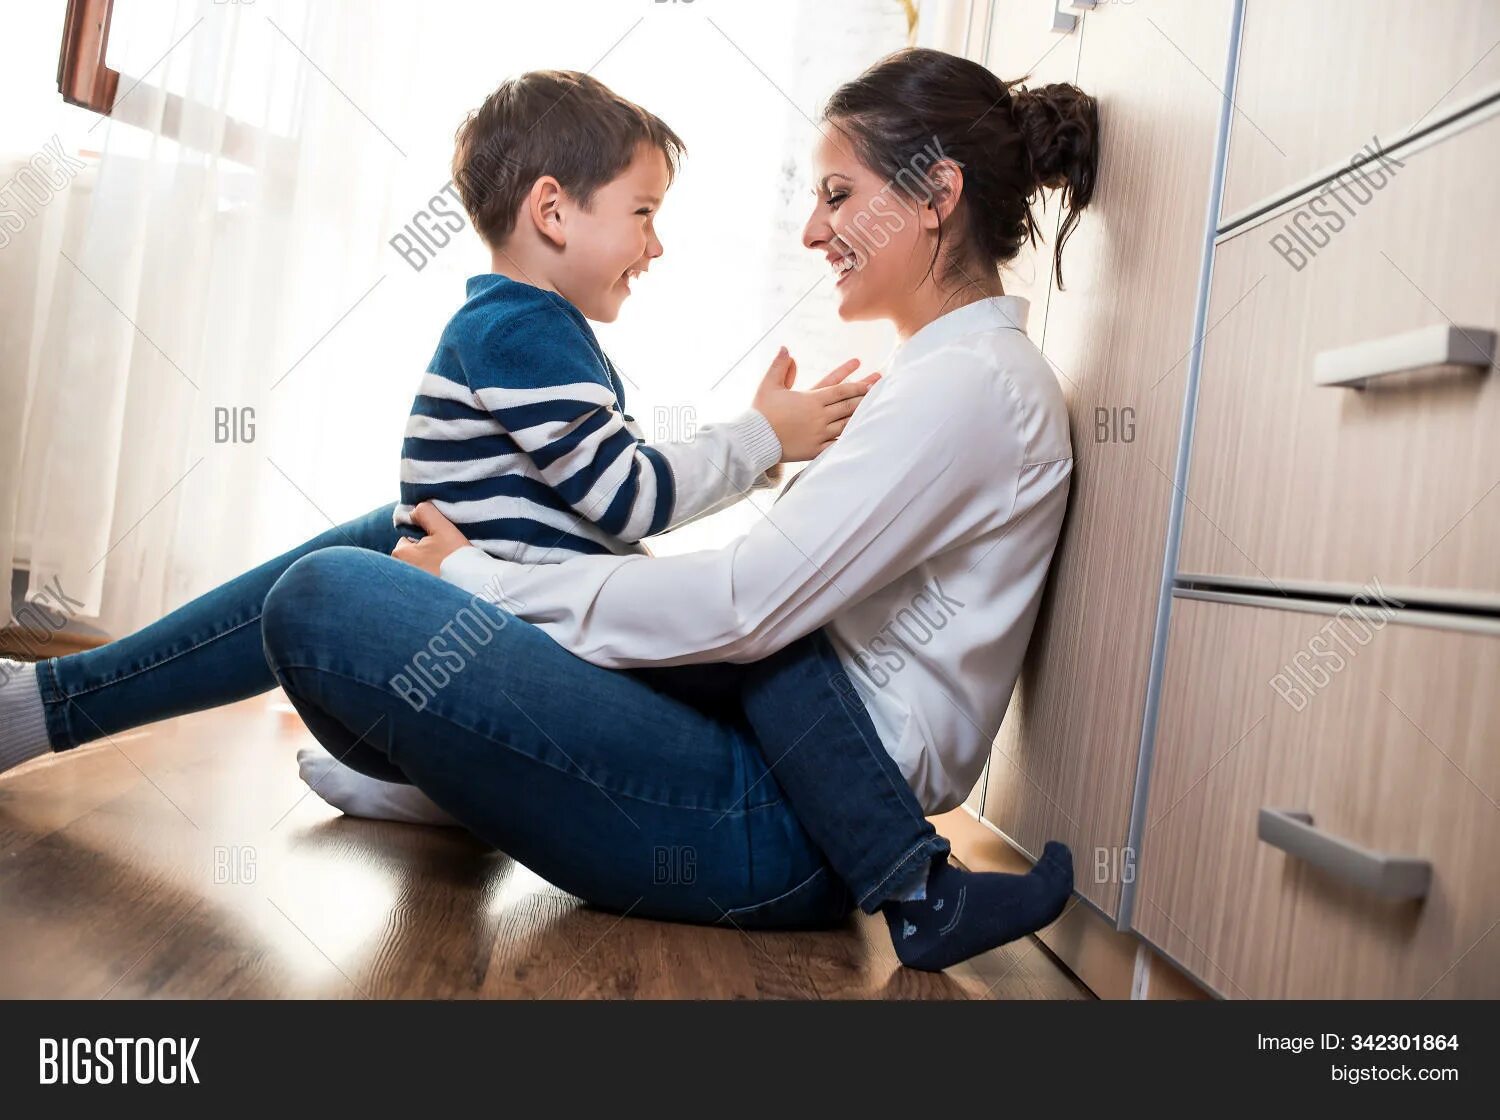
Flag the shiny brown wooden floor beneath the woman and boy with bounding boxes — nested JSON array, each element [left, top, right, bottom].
[[0, 699, 1091, 999]]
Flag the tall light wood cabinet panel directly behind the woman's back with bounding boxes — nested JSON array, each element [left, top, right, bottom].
[[984, 0, 1233, 915]]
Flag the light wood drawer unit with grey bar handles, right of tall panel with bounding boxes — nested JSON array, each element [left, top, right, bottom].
[[1131, 0, 1500, 999]]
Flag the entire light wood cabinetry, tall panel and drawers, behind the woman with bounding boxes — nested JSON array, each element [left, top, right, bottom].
[[969, 0, 1500, 997]]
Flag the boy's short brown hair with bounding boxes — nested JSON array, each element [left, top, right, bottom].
[[453, 70, 686, 246]]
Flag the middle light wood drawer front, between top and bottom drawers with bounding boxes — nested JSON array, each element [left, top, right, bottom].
[[1178, 109, 1500, 606]]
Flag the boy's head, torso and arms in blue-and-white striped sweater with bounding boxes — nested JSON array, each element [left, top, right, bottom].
[[396, 72, 867, 564]]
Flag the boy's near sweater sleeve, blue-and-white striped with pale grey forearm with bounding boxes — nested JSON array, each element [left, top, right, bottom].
[[464, 312, 782, 541]]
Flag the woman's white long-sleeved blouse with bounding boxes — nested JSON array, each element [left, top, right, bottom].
[[443, 295, 1073, 813]]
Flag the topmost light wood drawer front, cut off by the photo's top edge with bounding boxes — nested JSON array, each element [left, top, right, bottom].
[[1223, 0, 1500, 220]]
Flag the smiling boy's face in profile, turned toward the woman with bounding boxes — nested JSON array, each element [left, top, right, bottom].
[[557, 144, 671, 322]]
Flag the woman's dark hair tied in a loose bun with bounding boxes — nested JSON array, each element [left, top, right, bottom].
[[824, 48, 1100, 288]]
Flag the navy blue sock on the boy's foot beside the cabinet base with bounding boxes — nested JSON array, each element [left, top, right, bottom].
[[881, 840, 1073, 972]]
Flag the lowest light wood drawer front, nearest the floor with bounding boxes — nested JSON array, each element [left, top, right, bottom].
[[1133, 598, 1500, 999]]
